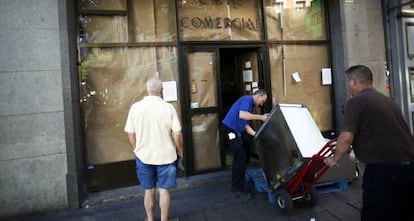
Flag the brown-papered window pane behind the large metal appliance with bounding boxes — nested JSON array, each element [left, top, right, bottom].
[[269, 45, 333, 131]]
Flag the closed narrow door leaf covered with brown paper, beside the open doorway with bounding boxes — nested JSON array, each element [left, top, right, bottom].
[[185, 49, 222, 173]]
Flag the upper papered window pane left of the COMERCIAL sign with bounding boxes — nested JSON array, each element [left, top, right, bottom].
[[79, 0, 176, 43]]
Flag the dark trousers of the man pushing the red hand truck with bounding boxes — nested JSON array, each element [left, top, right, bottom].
[[361, 162, 414, 221]]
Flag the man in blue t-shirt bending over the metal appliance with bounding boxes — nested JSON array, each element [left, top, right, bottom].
[[220, 89, 268, 199]]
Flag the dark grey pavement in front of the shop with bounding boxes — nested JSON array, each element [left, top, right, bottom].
[[6, 171, 362, 221]]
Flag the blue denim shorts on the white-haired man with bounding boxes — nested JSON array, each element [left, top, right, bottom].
[[135, 157, 177, 190]]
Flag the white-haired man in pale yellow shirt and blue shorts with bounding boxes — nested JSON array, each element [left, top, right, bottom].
[[125, 78, 183, 221]]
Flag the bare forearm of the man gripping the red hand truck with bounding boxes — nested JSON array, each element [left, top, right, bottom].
[[324, 131, 354, 167]]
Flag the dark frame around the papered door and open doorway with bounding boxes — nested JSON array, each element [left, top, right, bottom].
[[179, 43, 273, 176]]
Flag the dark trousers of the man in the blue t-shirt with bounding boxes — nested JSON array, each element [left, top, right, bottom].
[[220, 125, 249, 192]]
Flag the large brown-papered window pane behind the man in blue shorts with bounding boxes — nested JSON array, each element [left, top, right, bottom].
[[80, 47, 180, 164]]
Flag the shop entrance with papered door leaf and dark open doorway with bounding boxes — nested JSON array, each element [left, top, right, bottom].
[[182, 45, 270, 175]]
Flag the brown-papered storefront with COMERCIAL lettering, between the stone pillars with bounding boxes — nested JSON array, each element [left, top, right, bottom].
[[79, 0, 334, 191]]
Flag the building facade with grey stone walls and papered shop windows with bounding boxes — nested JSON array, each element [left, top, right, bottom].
[[0, 0, 414, 217]]
